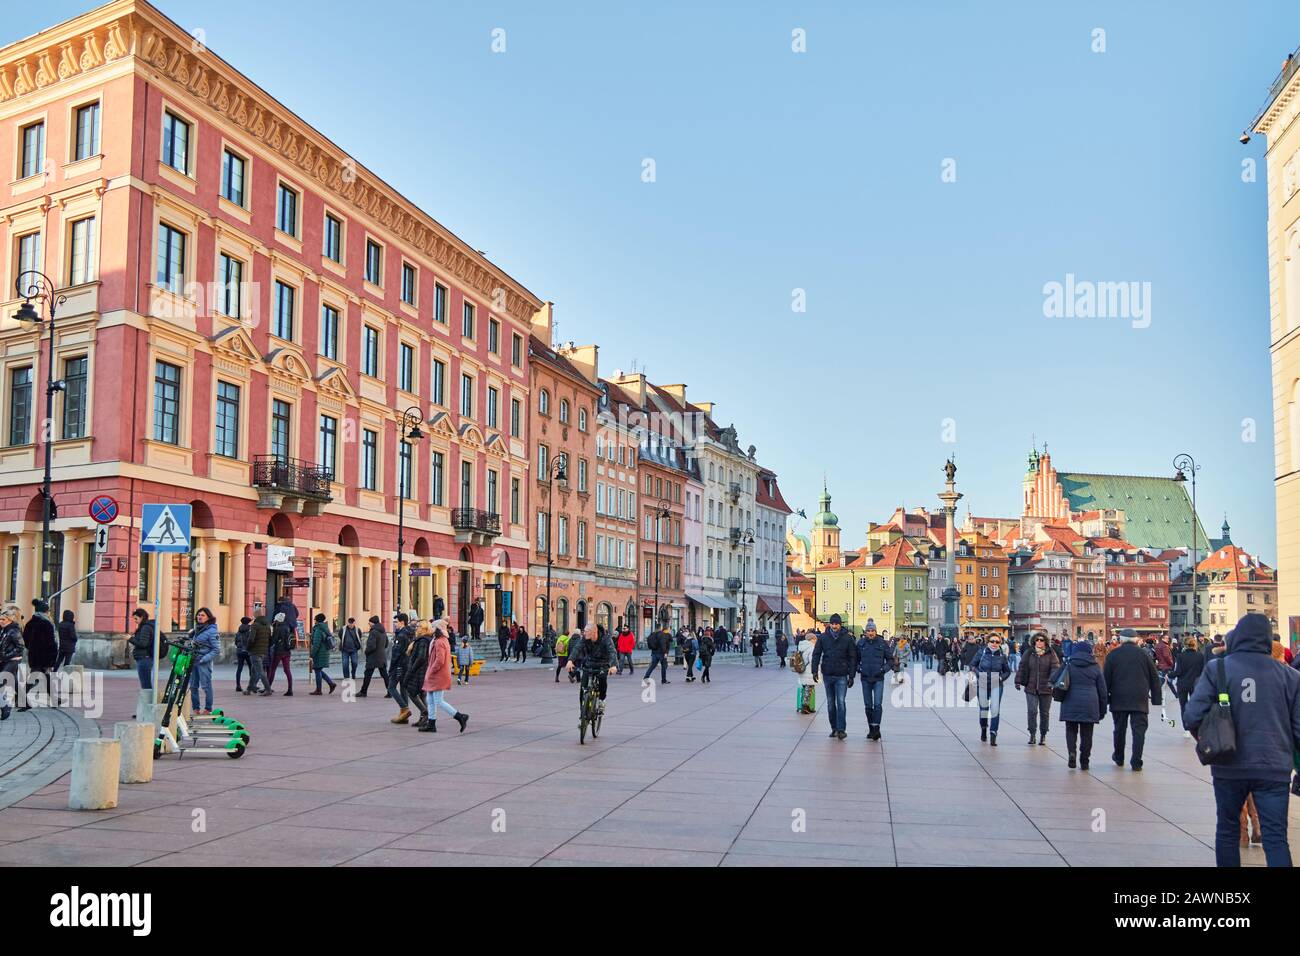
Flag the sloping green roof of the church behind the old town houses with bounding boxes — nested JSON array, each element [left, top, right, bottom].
[[1057, 472, 1209, 554]]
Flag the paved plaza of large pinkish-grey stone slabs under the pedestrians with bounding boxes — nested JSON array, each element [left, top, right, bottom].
[[0, 658, 1300, 866]]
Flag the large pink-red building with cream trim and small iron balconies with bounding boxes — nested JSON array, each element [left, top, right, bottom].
[[0, 0, 543, 647]]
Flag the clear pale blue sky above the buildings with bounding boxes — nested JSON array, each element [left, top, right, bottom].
[[15, 0, 1300, 562]]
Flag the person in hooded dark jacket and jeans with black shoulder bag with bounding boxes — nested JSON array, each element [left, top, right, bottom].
[[1183, 614, 1300, 866]]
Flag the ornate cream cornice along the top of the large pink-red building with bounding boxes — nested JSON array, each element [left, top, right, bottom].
[[0, 0, 542, 326]]
